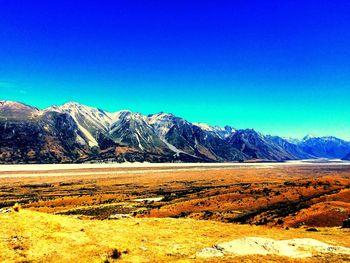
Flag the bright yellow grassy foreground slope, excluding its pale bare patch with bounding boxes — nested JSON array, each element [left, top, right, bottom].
[[0, 210, 350, 262]]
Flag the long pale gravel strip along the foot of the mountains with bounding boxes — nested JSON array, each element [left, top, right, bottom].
[[0, 160, 350, 178]]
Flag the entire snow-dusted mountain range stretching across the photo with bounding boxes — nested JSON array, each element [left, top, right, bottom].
[[0, 100, 350, 164]]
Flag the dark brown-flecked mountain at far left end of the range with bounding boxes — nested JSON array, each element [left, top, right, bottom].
[[0, 101, 89, 163]]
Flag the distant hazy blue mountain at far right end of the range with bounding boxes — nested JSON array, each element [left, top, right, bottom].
[[299, 135, 350, 159]]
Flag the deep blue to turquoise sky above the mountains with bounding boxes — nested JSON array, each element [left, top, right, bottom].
[[0, 0, 350, 140]]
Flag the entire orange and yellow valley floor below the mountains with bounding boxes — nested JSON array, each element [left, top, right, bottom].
[[0, 162, 350, 263]]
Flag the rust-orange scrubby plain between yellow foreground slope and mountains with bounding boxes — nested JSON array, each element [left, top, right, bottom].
[[0, 165, 350, 227]]
